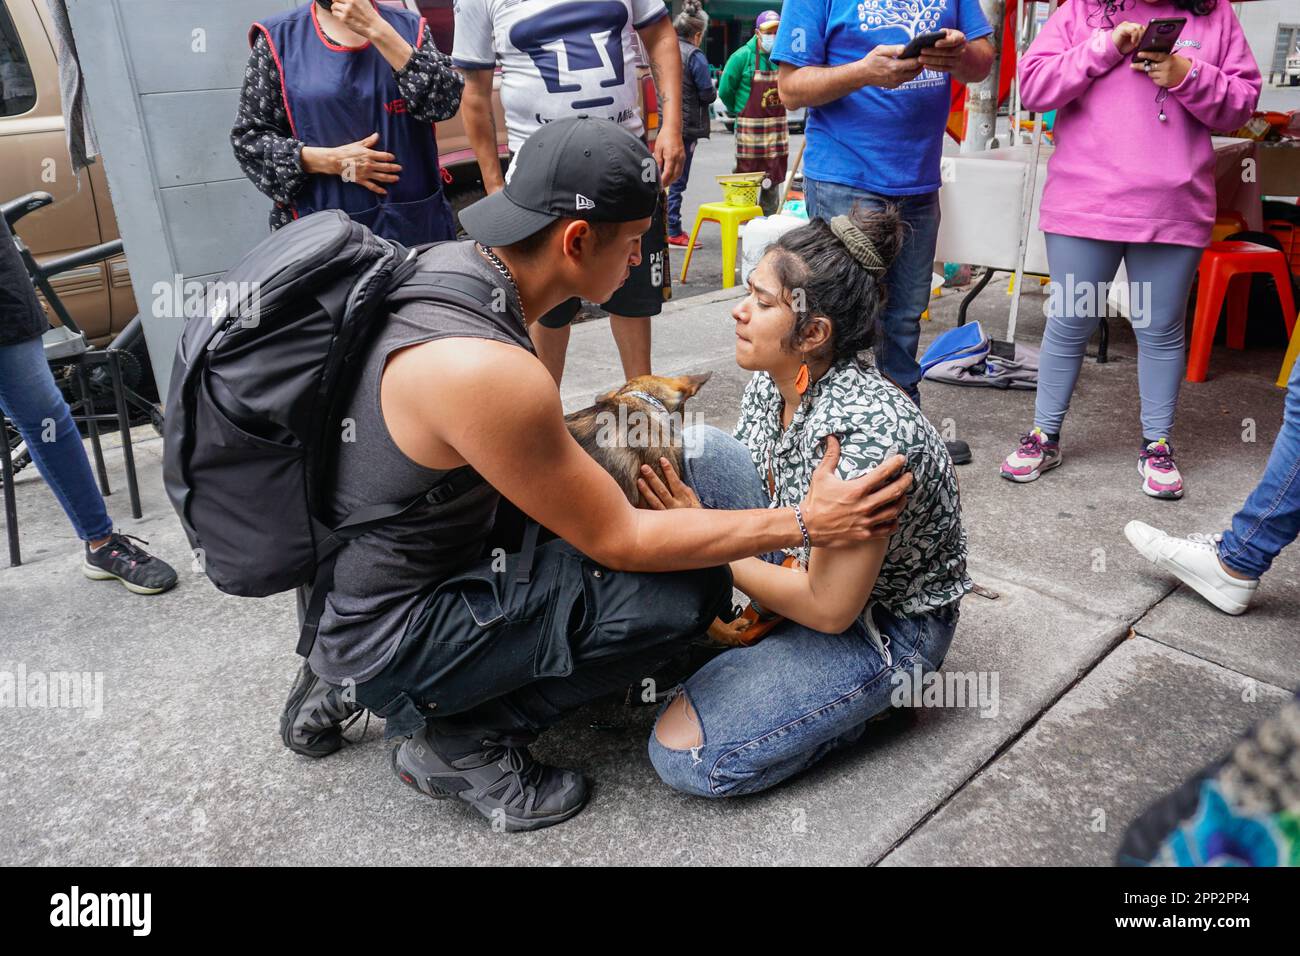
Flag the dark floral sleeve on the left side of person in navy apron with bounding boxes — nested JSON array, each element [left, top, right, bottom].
[[230, 35, 307, 204]]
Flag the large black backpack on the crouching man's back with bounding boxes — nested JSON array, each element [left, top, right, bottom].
[[163, 209, 494, 656]]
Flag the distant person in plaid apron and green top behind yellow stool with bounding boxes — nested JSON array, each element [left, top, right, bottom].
[[736, 10, 790, 216]]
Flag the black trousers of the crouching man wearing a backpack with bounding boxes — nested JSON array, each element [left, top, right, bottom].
[[356, 512, 732, 743]]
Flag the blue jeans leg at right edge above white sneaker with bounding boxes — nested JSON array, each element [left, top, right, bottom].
[[1219, 362, 1300, 578]]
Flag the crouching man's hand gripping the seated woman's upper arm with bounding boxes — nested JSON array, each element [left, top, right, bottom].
[[800, 436, 911, 548]]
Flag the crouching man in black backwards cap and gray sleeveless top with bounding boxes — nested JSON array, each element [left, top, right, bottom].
[[285, 117, 910, 830]]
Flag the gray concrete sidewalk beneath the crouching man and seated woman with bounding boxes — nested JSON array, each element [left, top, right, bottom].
[[0, 281, 1300, 865]]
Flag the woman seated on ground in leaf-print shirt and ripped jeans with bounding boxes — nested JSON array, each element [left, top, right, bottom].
[[641, 209, 971, 797]]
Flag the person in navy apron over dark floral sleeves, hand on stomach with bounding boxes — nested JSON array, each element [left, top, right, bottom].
[[231, 0, 463, 246]]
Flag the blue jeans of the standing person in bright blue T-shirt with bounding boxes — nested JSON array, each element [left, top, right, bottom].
[[803, 178, 939, 406]]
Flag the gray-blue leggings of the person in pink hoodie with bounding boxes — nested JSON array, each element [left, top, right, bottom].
[[1034, 233, 1201, 440]]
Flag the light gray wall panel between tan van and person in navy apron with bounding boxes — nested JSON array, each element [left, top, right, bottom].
[[68, 0, 298, 389]]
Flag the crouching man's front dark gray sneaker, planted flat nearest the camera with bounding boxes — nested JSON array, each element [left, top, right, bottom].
[[393, 732, 588, 832]]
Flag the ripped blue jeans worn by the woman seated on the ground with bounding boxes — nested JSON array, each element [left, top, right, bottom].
[[649, 425, 958, 797]]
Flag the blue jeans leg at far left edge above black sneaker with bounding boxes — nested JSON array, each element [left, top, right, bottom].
[[0, 338, 113, 541]]
